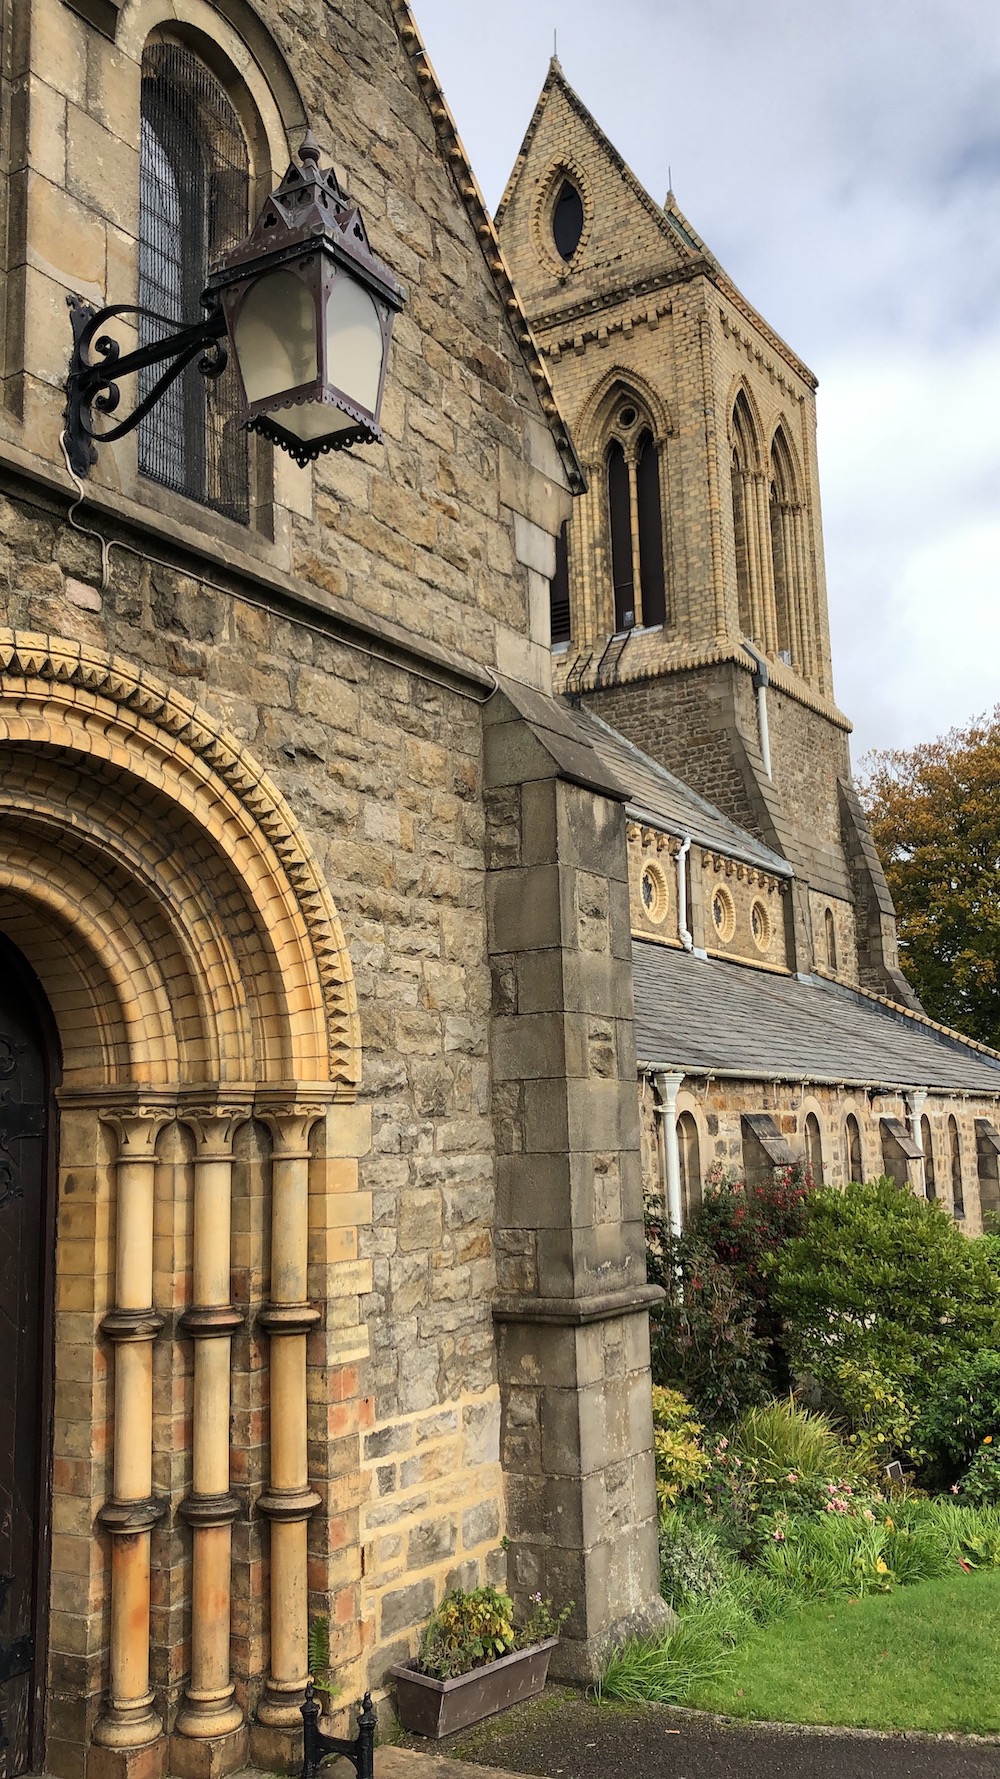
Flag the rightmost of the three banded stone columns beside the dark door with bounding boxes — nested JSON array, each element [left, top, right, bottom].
[[256, 1105, 322, 1731]]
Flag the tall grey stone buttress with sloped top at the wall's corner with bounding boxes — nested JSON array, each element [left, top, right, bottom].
[[484, 681, 669, 1679]]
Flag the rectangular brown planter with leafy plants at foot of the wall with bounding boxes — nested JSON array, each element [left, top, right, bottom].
[[390, 1587, 573, 1736]]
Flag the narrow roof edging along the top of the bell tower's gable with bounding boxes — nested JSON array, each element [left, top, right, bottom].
[[494, 55, 817, 388]]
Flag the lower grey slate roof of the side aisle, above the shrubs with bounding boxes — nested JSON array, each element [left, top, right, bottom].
[[632, 939, 1000, 1096]]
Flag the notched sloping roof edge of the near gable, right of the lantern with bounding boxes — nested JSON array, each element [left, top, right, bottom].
[[382, 0, 587, 495]]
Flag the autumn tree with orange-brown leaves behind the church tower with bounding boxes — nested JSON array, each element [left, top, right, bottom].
[[859, 704, 1000, 1048]]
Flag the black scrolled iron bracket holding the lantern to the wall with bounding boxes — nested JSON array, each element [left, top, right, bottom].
[[64, 292, 230, 477]]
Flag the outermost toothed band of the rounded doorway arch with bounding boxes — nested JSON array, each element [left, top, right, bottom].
[[0, 630, 359, 1087]]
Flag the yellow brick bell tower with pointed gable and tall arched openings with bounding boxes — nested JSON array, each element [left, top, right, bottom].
[[496, 57, 913, 1005]]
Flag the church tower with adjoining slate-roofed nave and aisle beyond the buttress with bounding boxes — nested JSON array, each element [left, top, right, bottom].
[[496, 59, 1000, 1233]]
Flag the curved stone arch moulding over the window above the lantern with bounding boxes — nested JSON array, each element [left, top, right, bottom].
[[116, 0, 308, 182]]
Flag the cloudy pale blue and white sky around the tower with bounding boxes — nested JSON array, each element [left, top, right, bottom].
[[415, 0, 1000, 760]]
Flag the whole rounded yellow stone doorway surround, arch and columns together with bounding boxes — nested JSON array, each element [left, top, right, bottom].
[[0, 632, 359, 1772]]
